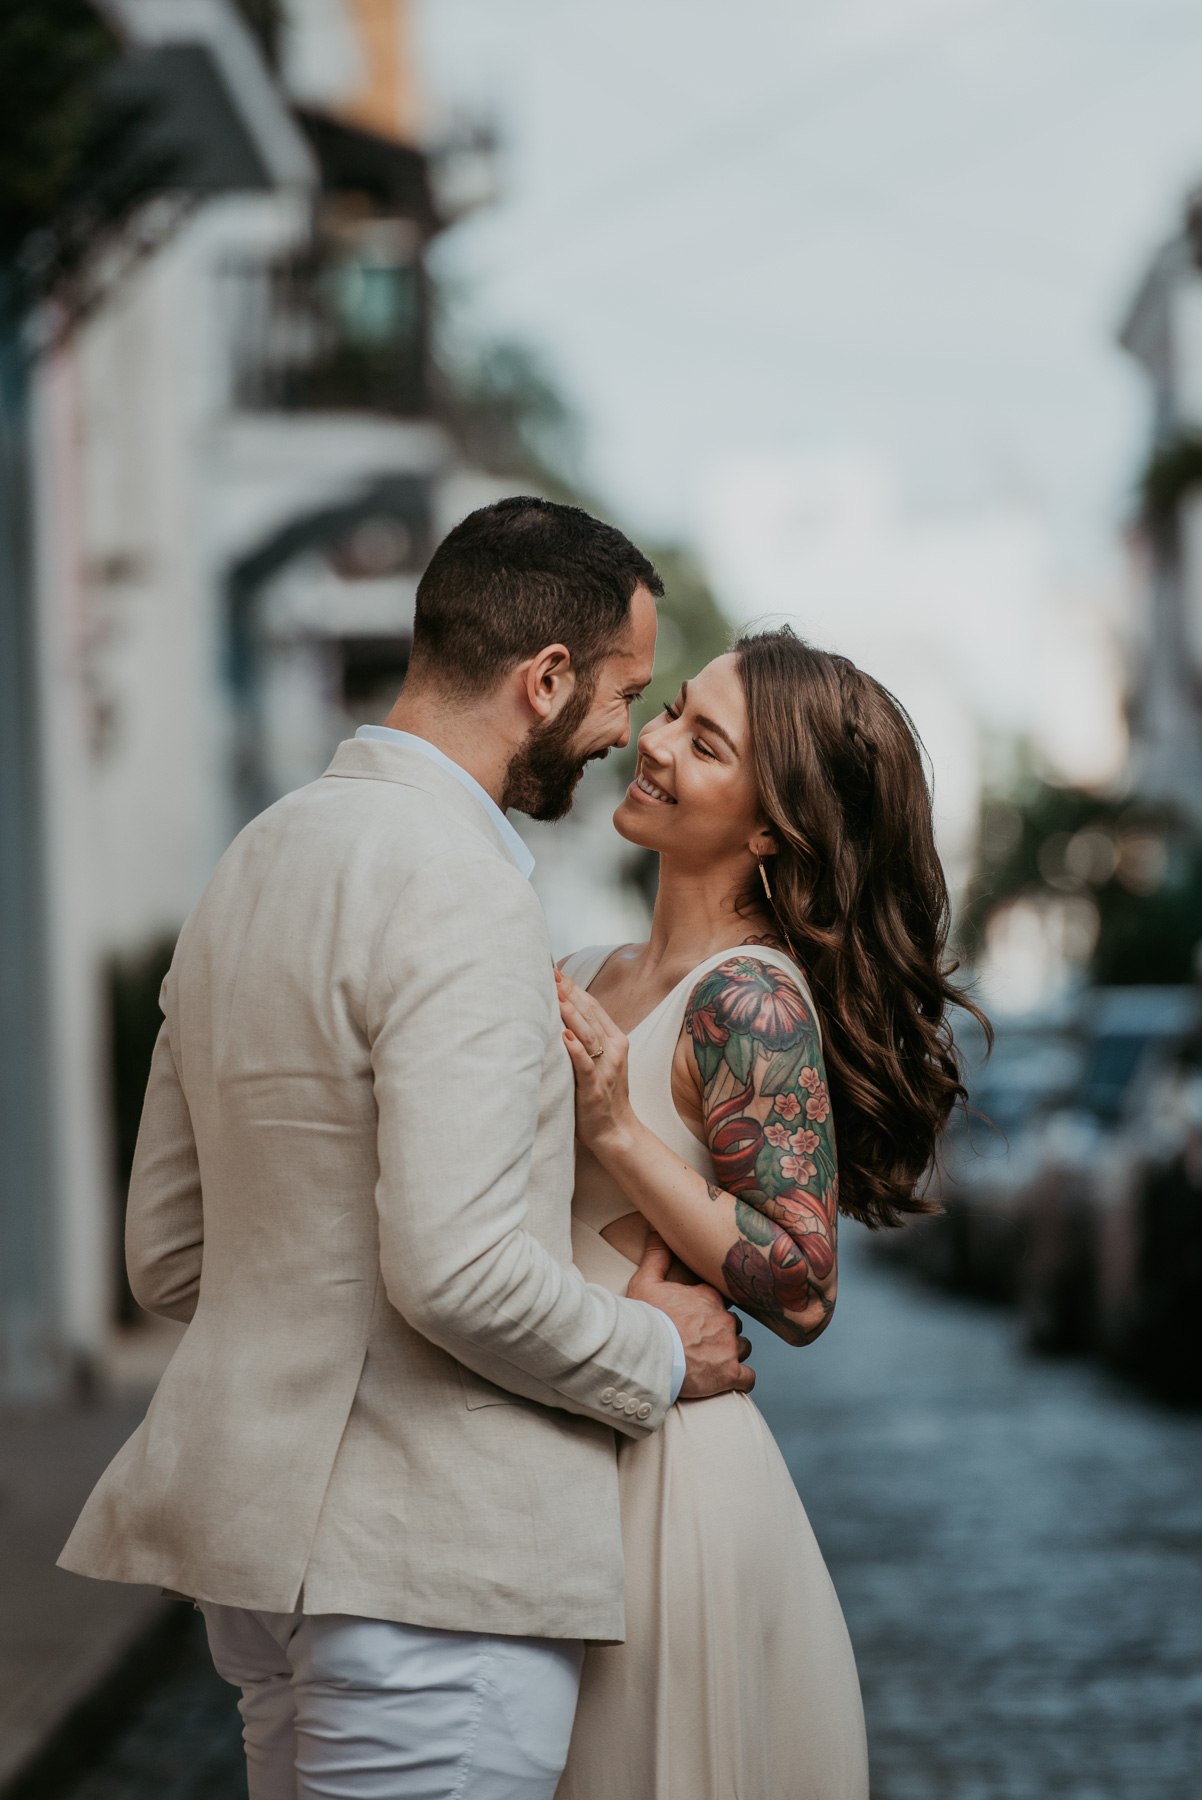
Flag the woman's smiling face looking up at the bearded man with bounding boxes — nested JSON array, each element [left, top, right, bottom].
[[614, 655, 776, 866]]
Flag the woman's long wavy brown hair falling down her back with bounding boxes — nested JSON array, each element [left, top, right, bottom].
[[734, 626, 990, 1226]]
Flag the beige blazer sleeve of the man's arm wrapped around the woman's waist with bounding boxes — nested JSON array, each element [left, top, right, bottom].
[[367, 853, 673, 1436]]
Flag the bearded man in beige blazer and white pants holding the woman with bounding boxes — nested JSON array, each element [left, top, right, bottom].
[[61, 499, 754, 1800]]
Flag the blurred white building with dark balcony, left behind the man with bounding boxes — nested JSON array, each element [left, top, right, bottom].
[[0, 0, 506, 1393]]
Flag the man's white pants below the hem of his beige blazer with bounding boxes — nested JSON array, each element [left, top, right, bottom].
[[202, 1602, 585, 1800]]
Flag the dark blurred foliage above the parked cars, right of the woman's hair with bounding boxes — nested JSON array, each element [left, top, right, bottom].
[[959, 781, 1202, 986]]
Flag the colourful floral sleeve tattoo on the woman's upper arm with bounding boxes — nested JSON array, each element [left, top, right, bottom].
[[686, 954, 839, 1343]]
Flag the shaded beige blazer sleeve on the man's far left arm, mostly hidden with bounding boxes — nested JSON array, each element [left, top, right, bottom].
[[126, 1015, 205, 1323]]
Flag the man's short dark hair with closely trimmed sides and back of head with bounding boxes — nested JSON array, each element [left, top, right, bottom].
[[412, 495, 664, 693]]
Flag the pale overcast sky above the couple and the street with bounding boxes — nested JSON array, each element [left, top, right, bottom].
[[419, 0, 1202, 569]]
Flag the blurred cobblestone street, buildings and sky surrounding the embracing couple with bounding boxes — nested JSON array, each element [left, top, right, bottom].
[[0, 0, 1202, 1800]]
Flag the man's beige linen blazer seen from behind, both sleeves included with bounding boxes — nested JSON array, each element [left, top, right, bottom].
[[61, 740, 673, 1640]]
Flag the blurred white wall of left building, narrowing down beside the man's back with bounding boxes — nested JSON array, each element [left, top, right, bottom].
[[32, 186, 314, 1364]]
